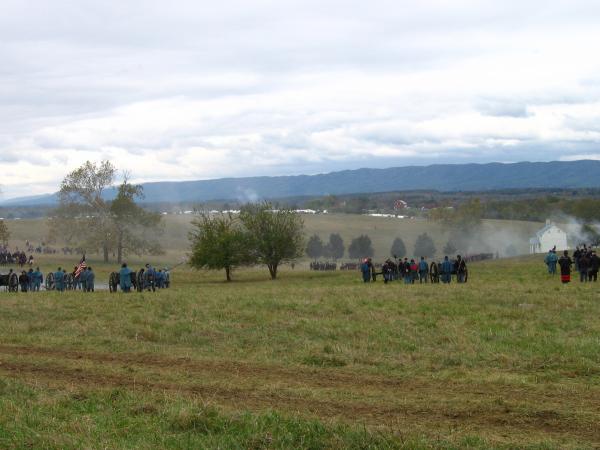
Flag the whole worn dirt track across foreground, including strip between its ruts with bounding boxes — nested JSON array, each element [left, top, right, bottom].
[[0, 345, 600, 443]]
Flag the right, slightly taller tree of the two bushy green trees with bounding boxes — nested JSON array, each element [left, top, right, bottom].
[[240, 203, 304, 280]]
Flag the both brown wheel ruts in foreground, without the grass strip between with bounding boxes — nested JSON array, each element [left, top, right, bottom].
[[0, 345, 600, 442]]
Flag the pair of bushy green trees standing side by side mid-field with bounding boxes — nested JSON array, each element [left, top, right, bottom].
[[189, 202, 304, 281]]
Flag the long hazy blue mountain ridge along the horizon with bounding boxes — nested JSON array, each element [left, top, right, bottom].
[[0, 160, 600, 206]]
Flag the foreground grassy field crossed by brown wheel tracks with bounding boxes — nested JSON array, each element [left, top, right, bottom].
[[0, 257, 600, 449]]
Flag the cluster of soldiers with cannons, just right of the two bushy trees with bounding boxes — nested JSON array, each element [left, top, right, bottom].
[[360, 255, 467, 284]]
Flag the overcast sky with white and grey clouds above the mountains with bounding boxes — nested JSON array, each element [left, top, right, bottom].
[[0, 0, 600, 198]]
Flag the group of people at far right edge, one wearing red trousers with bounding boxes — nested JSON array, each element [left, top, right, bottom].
[[544, 245, 600, 284]]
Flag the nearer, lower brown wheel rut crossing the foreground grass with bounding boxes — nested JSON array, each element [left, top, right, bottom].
[[0, 361, 600, 442]]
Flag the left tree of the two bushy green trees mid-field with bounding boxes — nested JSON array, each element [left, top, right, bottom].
[[189, 214, 253, 281]]
